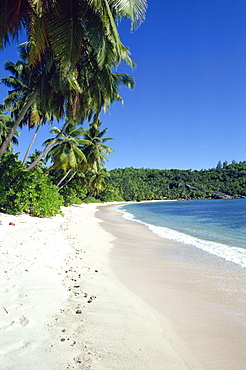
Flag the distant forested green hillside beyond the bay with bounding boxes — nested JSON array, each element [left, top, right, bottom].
[[97, 161, 246, 201]]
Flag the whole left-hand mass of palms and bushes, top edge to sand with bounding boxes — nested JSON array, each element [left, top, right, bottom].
[[0, 0, 147, 216]]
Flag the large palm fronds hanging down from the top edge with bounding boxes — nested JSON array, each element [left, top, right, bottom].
[[0, 0, 146, 66]]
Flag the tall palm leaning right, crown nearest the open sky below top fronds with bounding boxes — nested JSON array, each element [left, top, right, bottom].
[[27, 68, 135, 171]]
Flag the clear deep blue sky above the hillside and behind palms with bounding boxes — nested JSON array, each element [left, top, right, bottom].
[[0, 0, 246, 169]]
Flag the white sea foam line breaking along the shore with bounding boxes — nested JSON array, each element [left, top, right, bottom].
[[117, 207, 246, 268]]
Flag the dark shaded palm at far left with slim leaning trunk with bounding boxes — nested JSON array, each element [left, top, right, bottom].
[[0, 43, 72, 164]]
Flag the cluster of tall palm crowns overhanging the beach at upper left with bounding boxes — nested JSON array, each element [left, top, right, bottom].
[[0, 0, 146, 159]]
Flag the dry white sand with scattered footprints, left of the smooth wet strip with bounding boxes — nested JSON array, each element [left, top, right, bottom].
[[0, 204, 246, 370]]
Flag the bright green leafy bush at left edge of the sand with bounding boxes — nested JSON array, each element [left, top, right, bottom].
[[0, 153, 63, 217]]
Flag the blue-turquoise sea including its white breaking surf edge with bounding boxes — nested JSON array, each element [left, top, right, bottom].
[[118, 199, 246, 268]]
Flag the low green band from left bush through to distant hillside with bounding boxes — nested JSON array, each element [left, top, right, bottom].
[[0, 149, 246, 217]]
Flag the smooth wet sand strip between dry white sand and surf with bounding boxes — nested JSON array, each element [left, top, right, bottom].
[[97, 206, 246, 370]]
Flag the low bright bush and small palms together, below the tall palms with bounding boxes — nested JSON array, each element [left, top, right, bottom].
[[0, 119, 113, 217]]
